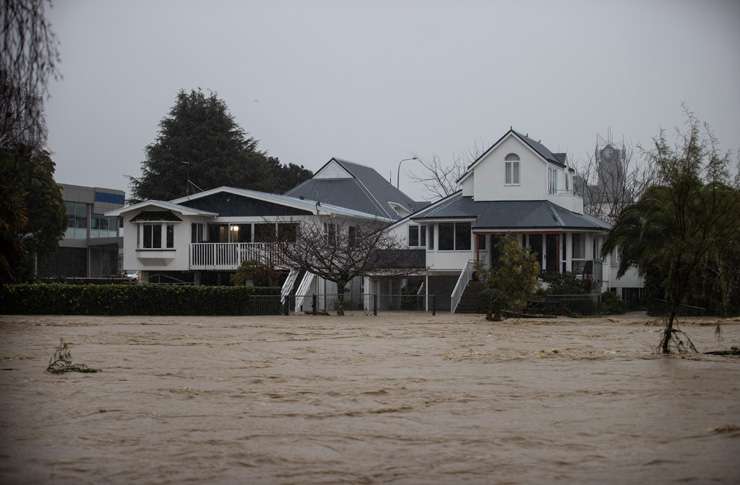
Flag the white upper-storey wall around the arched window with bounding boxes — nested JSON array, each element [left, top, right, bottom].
[[462, 135, 583, 213]]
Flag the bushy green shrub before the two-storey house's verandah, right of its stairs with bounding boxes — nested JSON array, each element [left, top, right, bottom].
[[479, 236, 540, 321]]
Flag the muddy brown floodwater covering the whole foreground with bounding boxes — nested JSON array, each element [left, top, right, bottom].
[[0, 313, 740, 483]]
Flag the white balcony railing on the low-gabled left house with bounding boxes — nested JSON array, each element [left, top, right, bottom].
[[190, 243, 284, 270]]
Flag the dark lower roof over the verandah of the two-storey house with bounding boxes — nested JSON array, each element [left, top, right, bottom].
[[411, 195, 610, 231]]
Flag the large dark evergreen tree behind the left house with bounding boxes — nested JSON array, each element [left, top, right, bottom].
[[131, 89, 311, 200]]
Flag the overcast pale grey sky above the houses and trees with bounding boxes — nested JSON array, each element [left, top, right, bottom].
[[47, 0, 740, 198]]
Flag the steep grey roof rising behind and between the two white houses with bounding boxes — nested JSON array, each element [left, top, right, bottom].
[[285, 157, 423, 220]]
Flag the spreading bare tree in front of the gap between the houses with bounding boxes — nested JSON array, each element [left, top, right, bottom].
[[277, 218, 399, 315]]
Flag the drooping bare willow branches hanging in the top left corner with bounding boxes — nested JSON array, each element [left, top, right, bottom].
[[0, 0, 59, 148]]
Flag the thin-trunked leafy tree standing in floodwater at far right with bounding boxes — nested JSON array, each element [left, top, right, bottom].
[[602, 113, 737, 353]]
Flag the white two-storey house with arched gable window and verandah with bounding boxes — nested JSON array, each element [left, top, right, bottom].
[[372, 129, 642, 311]]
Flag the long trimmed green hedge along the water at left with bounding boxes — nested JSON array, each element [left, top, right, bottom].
[[0, 283, 281, 315]]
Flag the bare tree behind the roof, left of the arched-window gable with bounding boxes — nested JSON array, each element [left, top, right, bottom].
[[409, 143, 485, 199]]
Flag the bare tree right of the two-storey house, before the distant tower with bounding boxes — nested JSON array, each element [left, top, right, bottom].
[[574, 143, 655, 223]]
